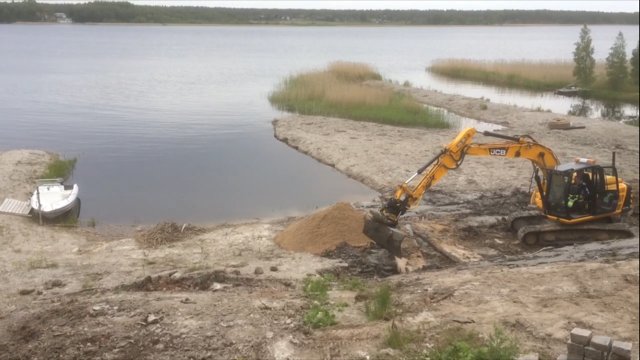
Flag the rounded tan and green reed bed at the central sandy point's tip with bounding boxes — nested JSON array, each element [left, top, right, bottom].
[[269, 62, 449, 128]]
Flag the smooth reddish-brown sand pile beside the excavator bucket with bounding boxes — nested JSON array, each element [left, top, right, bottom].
[[274, 203, 372, 255]]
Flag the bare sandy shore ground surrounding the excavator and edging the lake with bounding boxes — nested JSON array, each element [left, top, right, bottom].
[[0, 85, 639, 359]]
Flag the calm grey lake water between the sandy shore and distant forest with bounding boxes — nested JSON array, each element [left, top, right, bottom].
[[0, 24, 638, 224]]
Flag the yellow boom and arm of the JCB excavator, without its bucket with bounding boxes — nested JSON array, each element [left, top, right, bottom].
[[377, 128, 559, 226]]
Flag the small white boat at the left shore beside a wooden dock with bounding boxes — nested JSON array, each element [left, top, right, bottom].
[[31, 179, 79, 219]]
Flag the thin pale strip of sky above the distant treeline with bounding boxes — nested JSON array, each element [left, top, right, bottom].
[[27, 0, 639, 12]]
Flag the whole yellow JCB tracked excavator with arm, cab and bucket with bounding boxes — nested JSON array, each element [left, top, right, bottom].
[[363, 128, 633, 245]]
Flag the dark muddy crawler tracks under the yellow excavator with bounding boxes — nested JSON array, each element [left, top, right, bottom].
[[509, 212, 634, 246]]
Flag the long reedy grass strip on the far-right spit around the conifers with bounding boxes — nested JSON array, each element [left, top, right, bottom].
[[427, 59, 639, 104]]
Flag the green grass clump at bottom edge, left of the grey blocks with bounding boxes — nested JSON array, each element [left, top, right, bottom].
[[422, 327, 519, 360]]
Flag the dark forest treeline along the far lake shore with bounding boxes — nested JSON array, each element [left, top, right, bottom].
[[0, 0, 639, 25]]
